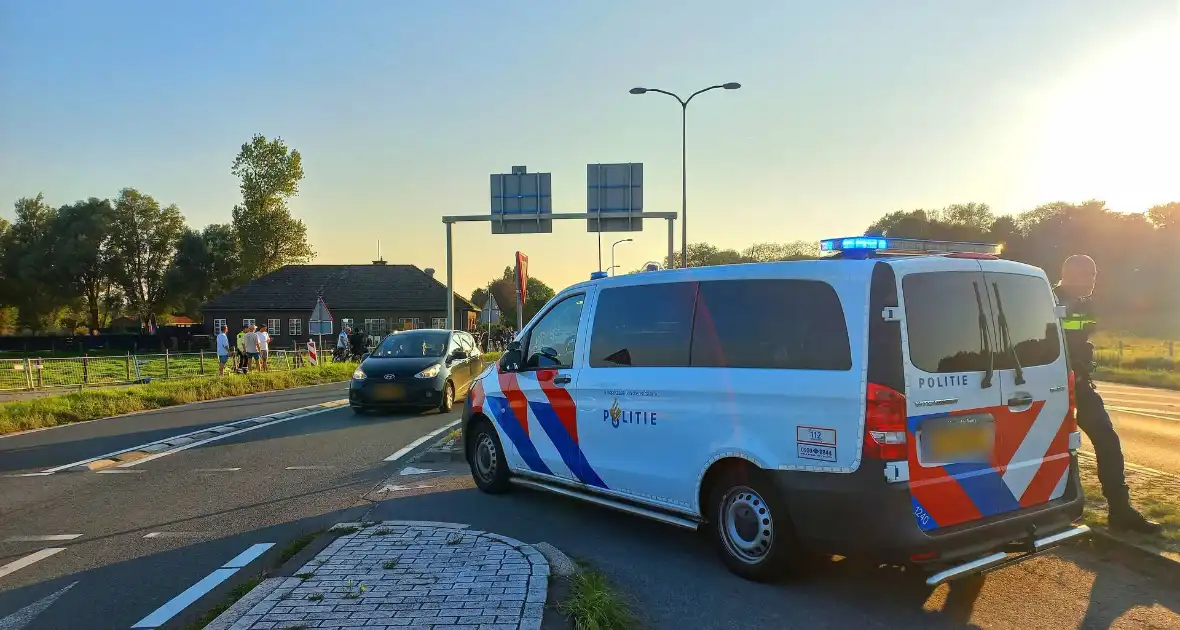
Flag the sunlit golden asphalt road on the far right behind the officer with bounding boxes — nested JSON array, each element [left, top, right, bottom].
[[1083, 382, 1180, 475]]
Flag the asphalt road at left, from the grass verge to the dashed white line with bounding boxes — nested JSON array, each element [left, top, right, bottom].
[[0, 385, 458, 630]]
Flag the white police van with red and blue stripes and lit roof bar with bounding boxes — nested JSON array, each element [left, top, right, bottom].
[[463, 237, 1089, 585]]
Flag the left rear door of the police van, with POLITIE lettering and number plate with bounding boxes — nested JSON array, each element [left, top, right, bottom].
[[891, 256, 1020, 531]]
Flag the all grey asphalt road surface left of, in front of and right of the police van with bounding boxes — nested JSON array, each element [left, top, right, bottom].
[[0, 385, 1180, 630]]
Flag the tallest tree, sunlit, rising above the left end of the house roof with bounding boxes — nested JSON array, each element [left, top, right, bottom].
[[230, 134, 315, 280]]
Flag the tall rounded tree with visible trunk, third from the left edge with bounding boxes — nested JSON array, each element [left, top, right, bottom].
[[110, 188, 184, 323]]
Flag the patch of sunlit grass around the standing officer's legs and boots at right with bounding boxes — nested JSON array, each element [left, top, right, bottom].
[[1079, 458, 1180, 562]]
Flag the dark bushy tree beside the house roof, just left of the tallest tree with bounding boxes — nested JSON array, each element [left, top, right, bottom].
[[164, 224, 241, 314]]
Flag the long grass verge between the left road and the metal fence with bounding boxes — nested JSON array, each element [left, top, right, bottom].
[[0, 363, 356, 435]]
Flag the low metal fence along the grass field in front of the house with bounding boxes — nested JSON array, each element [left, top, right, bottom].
[[0, 349, 309, 392]]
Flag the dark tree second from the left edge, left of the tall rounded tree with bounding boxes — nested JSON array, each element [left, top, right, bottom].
[[50, 197, 114, 329]]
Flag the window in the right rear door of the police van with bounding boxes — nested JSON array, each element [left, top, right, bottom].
[[983, 271, 1061, 369]]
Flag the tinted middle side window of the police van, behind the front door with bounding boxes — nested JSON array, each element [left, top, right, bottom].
[[590, 282, 696, 367]]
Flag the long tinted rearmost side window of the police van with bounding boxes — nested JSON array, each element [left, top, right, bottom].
[[691, 280, 852, 370]]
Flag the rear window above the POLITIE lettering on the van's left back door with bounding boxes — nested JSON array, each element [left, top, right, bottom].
[[902, 271, 995, 374]]
